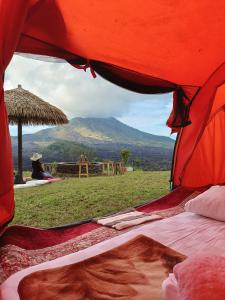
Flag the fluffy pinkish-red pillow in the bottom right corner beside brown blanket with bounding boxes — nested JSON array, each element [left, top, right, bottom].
[[162, 256, 225, 300]]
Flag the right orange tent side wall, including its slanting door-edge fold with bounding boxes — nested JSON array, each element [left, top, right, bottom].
[[173, 63, 225, 187]]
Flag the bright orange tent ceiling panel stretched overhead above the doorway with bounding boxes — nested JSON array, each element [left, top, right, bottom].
[[17, 0, 225, 86]]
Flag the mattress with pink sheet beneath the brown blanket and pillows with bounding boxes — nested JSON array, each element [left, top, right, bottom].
[[1, 212, 225, 300]]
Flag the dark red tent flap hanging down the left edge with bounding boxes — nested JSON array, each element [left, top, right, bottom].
[[0, 0, 35, 226]]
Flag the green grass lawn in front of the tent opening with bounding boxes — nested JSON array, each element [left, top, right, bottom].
[[13, 171, 170, 227]]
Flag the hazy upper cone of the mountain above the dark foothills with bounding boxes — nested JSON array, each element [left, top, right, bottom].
[[35, 118, 174, 149]]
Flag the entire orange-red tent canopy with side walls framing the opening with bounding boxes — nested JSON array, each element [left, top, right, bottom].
[[0, 0, 225, 225]]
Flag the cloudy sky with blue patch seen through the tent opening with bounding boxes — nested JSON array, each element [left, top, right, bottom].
[[5, 55, 172, 136]]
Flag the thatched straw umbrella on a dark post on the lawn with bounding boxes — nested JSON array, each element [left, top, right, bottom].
[[5, 85, 68, 183]]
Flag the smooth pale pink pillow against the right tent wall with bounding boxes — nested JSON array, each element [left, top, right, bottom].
[[184, 185, 225, 221]]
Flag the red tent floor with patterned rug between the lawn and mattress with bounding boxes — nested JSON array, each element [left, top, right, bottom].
[[0, 188, 200, 282]]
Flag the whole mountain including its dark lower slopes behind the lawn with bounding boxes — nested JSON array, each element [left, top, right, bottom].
[[12, 118, 174, 170]]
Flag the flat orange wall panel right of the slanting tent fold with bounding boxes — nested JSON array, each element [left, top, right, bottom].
[[182, 107, 225, 186]]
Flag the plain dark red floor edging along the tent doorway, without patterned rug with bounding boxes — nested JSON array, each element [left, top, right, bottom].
[[0, 187, 200, 250]]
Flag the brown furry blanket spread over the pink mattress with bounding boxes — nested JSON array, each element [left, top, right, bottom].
[[18, 235, 185, 300]]
